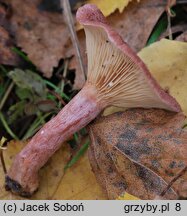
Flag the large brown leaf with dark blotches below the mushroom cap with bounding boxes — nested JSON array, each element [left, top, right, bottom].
[[89, 109, 187, 199]]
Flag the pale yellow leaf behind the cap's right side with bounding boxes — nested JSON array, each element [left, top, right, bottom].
[[138, 39, 187, 114]]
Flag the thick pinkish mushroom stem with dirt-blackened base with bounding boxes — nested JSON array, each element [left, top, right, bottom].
[[6, 84, 103, 196]]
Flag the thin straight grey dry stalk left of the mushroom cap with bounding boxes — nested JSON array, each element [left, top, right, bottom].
[[60, 0, 86, 80]]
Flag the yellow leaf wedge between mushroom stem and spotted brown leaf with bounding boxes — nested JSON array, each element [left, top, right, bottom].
[[52, 148, 107, 200]]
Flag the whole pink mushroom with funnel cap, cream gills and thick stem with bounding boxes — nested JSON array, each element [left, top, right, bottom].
[[5, 4, 181, 196]]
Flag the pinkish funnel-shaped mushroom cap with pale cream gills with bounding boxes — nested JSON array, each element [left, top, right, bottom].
[[77, 4, 181, 112]]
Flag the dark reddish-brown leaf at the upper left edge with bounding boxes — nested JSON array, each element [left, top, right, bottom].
[[0, 2, 19, 65]]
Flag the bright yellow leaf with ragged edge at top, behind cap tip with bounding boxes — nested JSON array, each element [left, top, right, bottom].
[[86, 0, 132, 16]]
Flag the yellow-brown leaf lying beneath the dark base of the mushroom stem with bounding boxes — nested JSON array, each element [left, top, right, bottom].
[[0, 141, 70, 199]]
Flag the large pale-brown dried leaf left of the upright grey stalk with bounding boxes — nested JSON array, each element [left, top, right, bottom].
[[7, 0, 70, 77]]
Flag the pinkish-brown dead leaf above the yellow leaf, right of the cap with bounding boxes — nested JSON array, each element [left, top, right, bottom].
[[108, 0, 165, 52]]
